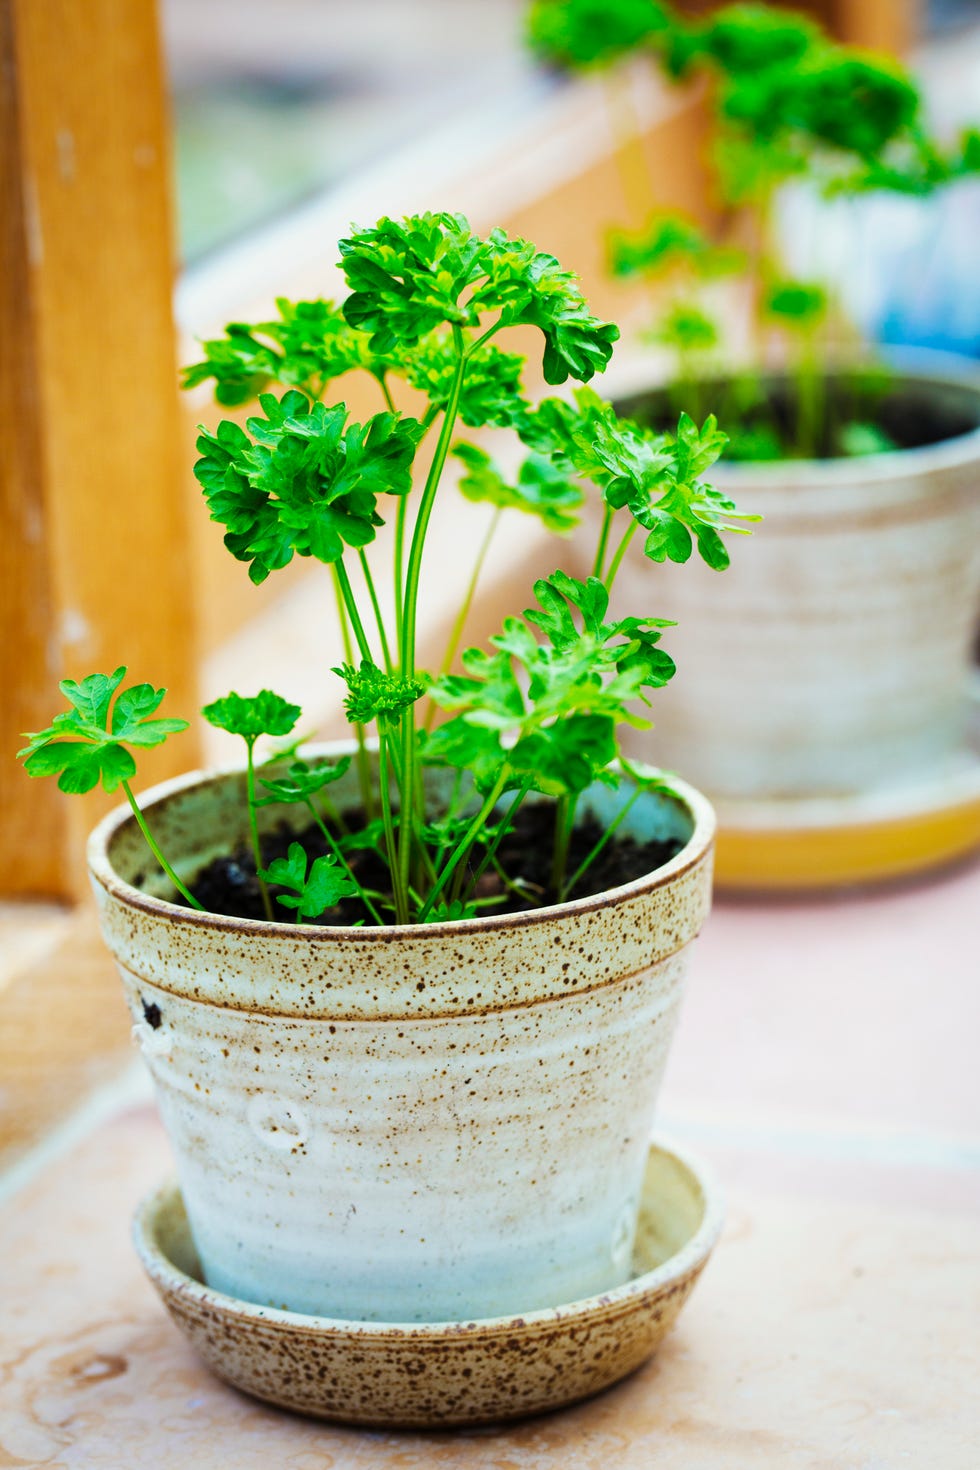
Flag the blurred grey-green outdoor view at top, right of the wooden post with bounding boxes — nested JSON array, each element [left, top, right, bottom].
[[170, 0, 560, 266]]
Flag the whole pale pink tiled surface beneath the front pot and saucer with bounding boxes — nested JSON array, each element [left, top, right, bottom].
[[0, 867, 980, 1470]]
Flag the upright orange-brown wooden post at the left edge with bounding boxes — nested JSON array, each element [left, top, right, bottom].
[[0, 0, 197, 898]]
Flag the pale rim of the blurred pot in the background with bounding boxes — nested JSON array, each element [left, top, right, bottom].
[[607, 347, 980, 490]]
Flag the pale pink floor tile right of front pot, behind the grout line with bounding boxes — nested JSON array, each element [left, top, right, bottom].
[[664, 863, 980, 1145]]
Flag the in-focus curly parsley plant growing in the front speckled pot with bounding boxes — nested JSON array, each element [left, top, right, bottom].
[[24, 210, 752, 925]]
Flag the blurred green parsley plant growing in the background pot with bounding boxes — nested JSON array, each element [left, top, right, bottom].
[[526, 0, 980, 459]]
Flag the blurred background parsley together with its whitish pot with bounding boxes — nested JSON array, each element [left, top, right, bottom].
[[529, 0, 980, 882]]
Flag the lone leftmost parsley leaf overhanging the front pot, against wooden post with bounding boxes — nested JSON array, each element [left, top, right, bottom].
[[18, 664, 188, 794]]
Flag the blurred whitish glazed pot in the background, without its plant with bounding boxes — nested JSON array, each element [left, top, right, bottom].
[[614, 361, 980, 800]]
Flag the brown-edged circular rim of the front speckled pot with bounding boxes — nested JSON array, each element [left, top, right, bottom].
[[87, 741, 717, 944]]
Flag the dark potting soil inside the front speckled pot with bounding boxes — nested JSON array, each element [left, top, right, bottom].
[[182, 803, 682, 925]]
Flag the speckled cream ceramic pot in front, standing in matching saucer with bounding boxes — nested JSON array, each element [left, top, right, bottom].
[[88, 746, 714, 1322]]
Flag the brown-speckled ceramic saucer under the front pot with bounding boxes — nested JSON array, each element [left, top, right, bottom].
[[134, 1144, 723, 1429]]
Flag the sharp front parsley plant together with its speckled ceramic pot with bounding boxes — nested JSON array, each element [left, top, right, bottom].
[[22, 215, 752, 1322]]
